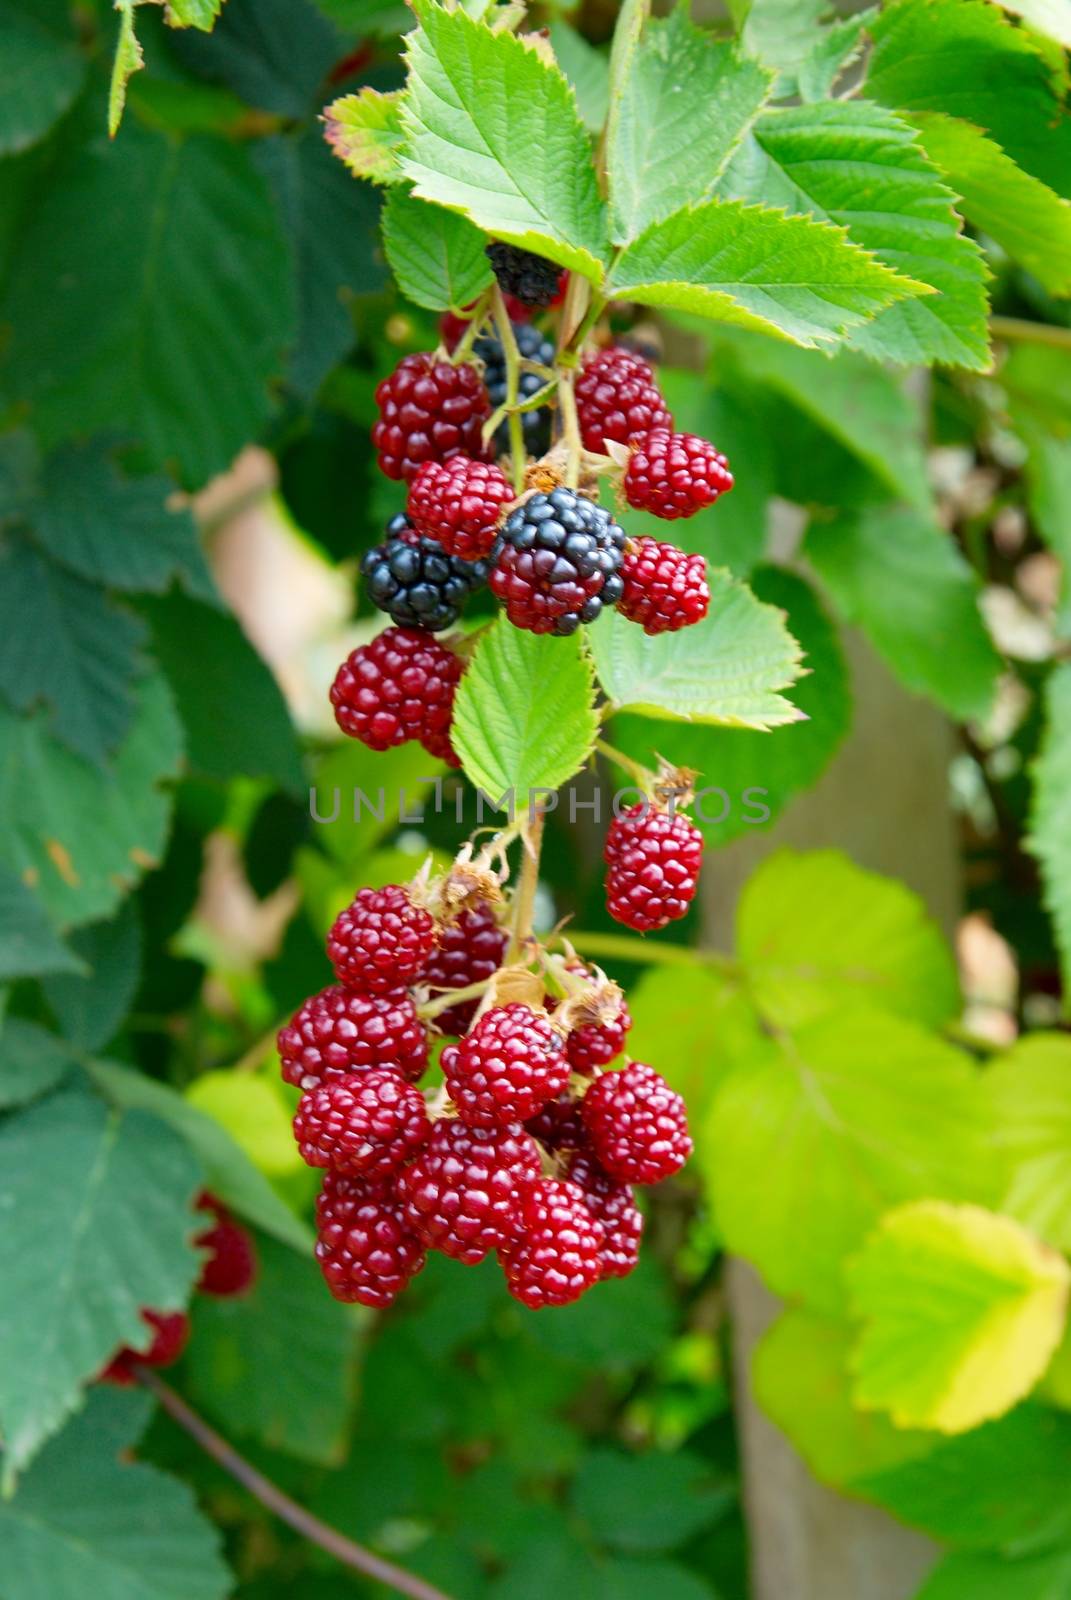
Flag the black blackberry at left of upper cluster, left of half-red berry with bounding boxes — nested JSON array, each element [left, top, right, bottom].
[[360, 512, 488, 634]]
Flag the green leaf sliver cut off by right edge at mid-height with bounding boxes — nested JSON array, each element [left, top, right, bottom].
[[1028, 661, 1071, 998]]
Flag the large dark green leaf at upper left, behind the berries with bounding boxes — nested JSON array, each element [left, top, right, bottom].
[[2, 125, 293, 486]]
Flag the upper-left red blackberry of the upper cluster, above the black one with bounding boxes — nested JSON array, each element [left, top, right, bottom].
[[371, 354, 490, 483]]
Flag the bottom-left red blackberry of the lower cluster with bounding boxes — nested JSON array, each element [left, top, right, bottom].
[[315, 1171, 426, 1310]]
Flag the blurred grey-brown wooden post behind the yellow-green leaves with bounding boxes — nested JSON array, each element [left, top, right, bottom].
[[703, 635, 961, 1600]]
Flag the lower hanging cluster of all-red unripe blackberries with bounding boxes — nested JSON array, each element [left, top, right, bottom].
[[279, 885, 692, 1309]]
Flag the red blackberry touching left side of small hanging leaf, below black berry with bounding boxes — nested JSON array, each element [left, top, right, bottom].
[[331, 627, 464, 766]]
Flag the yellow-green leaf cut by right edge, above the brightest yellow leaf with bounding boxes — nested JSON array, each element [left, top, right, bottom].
[[986, 1034, 1071, 1251]]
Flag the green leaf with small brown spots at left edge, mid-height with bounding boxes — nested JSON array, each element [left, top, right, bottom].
[[0, 675, 183, 925]]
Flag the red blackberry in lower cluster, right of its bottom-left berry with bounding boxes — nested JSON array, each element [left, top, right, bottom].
[[397, 1117, 540, 1266]]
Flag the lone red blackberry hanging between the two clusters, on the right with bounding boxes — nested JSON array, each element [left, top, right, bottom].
[[604, 802, 703, 933]]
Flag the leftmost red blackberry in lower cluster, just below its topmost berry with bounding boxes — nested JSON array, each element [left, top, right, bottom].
[[279, 984, 427, 1090]]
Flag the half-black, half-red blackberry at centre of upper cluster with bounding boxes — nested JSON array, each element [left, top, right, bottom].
[[488, 488, 624, 634]]
